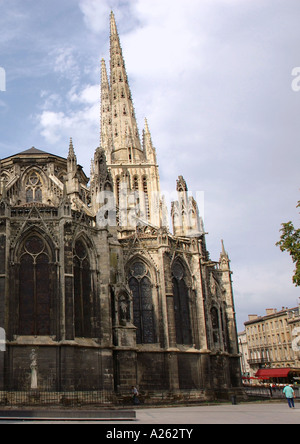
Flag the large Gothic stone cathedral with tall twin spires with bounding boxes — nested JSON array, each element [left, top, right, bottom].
[[0, 13, 241, 402]]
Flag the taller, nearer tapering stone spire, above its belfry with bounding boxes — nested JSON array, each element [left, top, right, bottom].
[[109, 12, 144, 163]]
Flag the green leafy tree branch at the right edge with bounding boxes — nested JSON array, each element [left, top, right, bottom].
[[276, 201, 300, 287]]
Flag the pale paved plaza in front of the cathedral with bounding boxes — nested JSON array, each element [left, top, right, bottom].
[[0, 401, 300, 424]]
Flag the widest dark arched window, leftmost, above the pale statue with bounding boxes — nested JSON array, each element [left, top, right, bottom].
[[19, 236, 51, 336]]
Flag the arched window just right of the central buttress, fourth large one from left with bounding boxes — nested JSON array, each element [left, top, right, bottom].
[[172, 261, 192, 345]]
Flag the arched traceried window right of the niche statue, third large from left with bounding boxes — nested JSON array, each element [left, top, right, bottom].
[[129, 262, 156, 344]]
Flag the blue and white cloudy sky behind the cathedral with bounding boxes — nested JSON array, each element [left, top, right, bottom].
[[0, 0, 300, 330]]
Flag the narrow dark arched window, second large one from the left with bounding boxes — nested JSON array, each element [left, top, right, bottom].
[[74, 240, 91, 338]]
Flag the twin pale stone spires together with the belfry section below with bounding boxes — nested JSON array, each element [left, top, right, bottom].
[[101, 13, 161, 231]]
